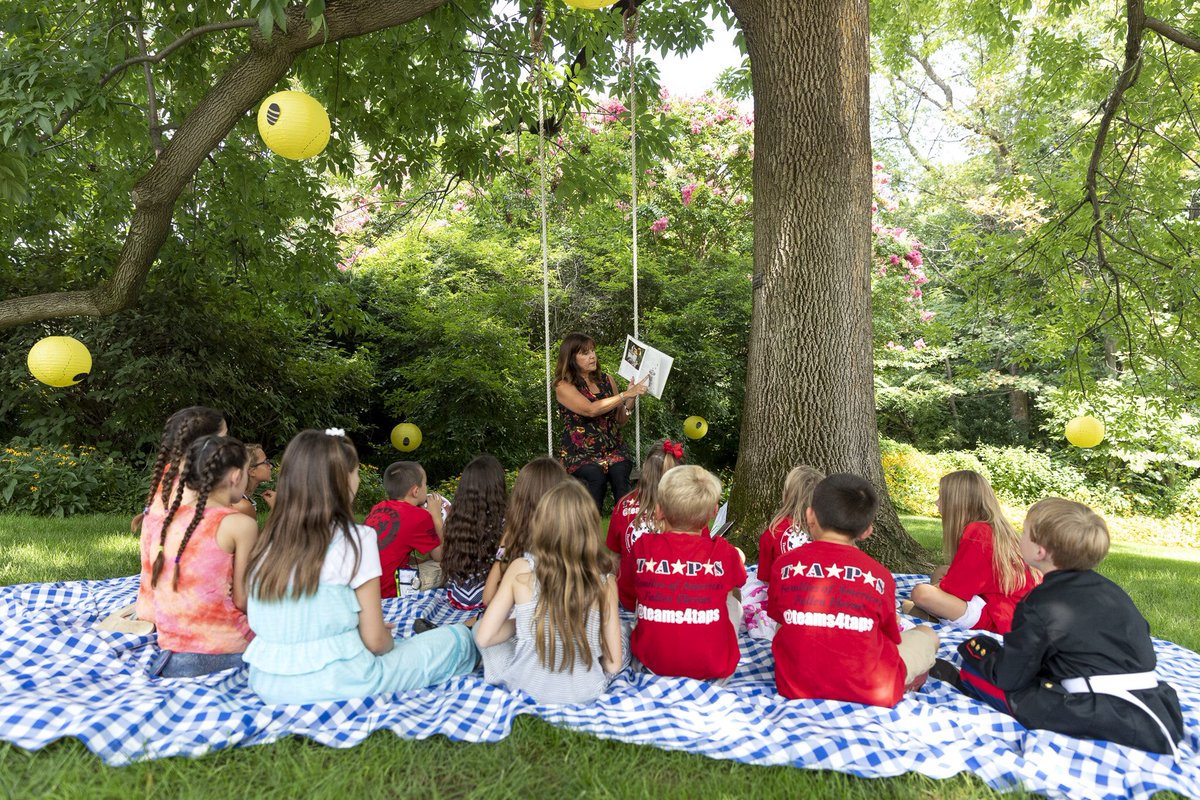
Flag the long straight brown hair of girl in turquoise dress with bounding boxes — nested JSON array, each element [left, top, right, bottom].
[[246, 431, 362, 601]]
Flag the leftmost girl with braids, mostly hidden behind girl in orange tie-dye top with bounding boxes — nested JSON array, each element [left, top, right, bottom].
[[136, 405, 229, 622]]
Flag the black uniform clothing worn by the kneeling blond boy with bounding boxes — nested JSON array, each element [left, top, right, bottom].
[[964, 570, 1183, 753]]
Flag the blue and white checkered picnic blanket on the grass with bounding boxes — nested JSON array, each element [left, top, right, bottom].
[[0, 576, 1200, 799]]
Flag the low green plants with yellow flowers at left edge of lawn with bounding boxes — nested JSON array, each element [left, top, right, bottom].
[[0, 439, 140, 517]]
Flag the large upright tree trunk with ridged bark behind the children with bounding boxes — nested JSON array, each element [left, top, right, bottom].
[[730, 0, 925, 570]]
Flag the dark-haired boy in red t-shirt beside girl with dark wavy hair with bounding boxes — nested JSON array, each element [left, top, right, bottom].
[[364, 461, 442, 597]]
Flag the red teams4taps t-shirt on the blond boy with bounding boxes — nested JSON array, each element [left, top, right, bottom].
[[629, 531, 746, 680]]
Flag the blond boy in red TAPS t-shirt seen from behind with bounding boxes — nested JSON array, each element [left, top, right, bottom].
[[630, 467, 746, 680]]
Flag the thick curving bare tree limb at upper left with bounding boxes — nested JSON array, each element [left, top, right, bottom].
[[0, 0, 446, 329]]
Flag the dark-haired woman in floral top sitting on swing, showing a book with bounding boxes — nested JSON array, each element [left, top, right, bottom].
[[554, 333, 649, 510]]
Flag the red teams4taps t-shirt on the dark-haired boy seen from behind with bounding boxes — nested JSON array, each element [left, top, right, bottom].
[[767, 541, 905, 708]]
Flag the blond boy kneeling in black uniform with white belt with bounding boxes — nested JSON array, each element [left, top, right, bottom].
[[931, 498, 1183, 753]]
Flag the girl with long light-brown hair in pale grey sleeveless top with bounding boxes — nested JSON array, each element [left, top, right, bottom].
[[475, 479, 623, 703]]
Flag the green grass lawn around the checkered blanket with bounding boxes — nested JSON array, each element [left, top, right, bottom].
[[0, 516, 1200, 800]]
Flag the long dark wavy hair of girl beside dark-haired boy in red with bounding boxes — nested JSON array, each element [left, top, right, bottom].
[[446, 453, 506, 583]]
